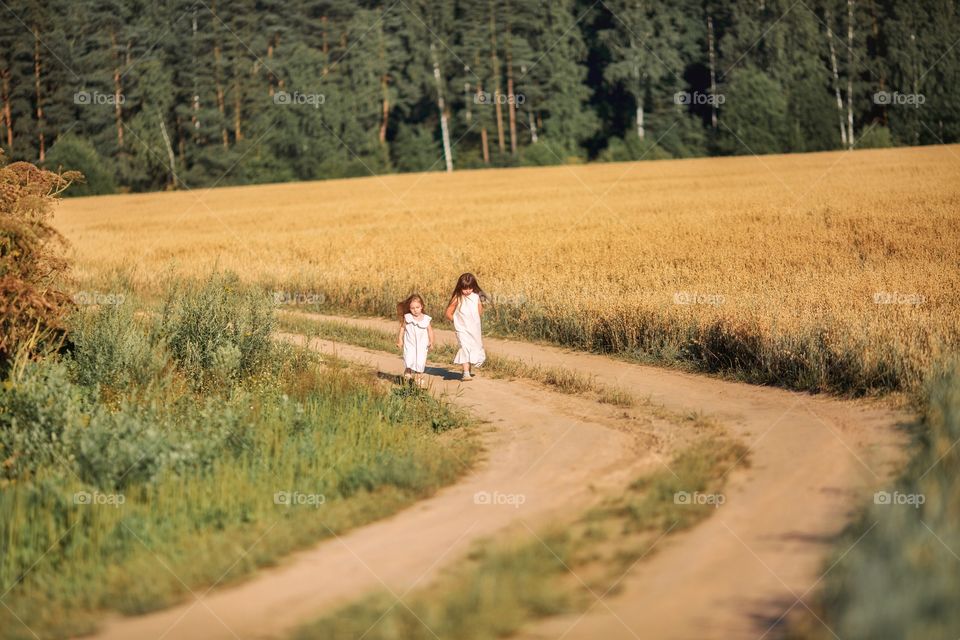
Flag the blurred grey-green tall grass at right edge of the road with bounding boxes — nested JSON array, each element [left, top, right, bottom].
[[784, 364, 960, 640]]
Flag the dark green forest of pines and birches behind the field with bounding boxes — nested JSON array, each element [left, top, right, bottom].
[[0, 0, 960, 193]]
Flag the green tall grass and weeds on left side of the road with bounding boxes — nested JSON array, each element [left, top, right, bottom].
[[0, 276, 473, 638]]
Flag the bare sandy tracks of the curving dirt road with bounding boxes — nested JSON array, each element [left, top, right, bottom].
[[86, 319, 907, 640]]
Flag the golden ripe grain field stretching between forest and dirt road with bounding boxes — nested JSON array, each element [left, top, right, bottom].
[[56, 145, 960, 393]]
